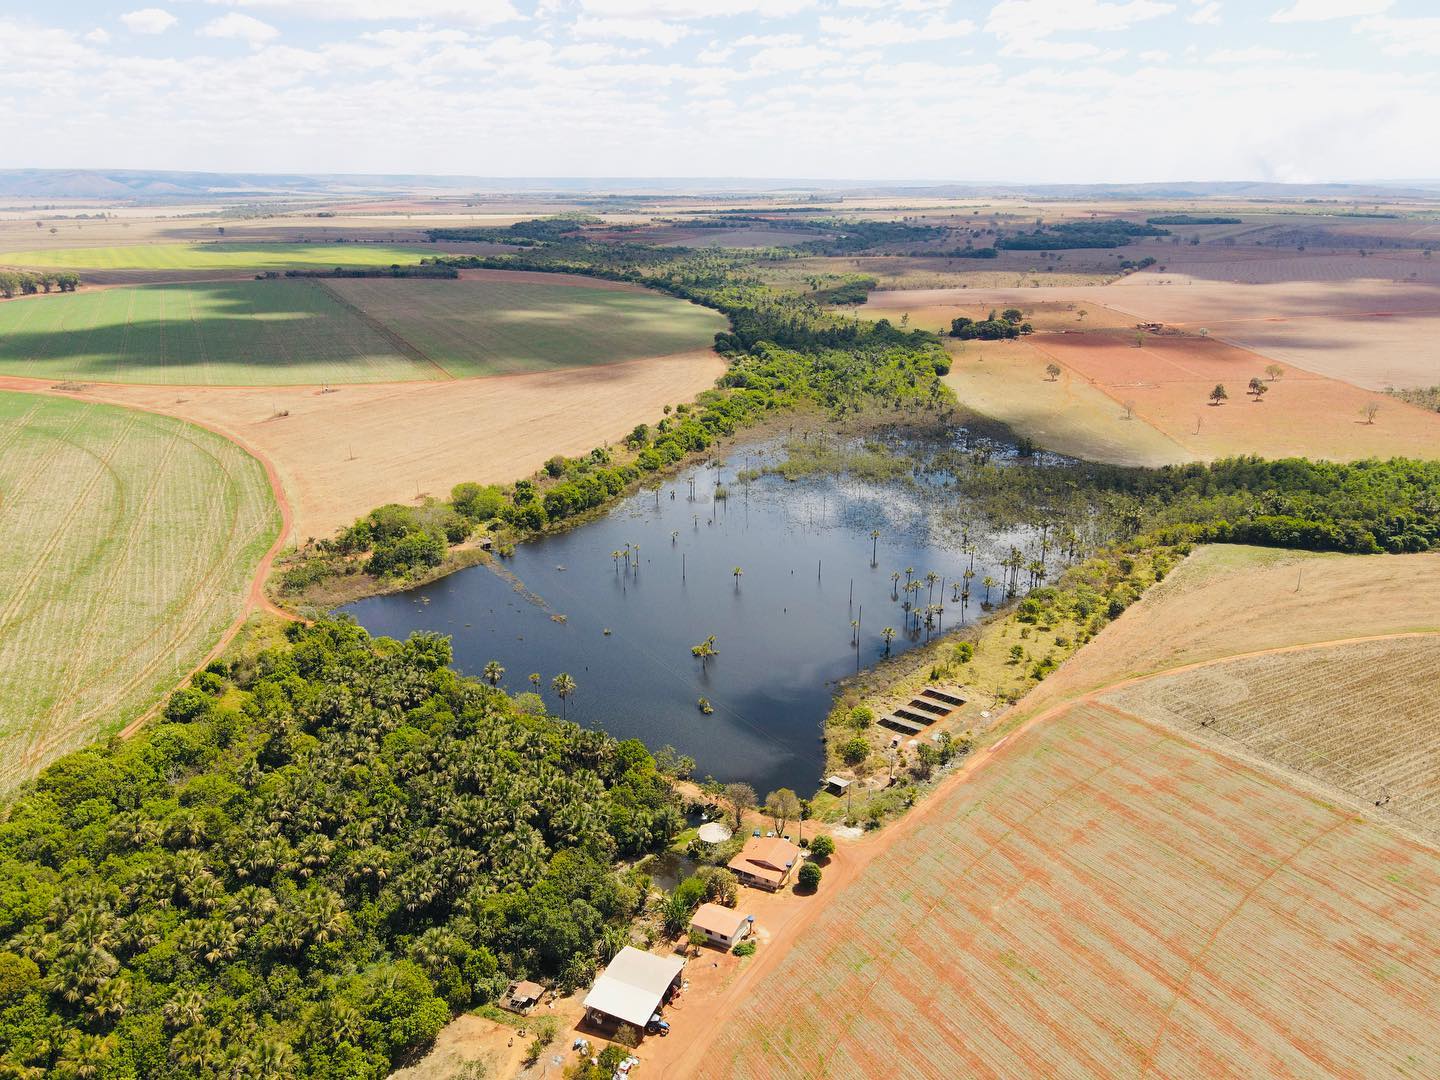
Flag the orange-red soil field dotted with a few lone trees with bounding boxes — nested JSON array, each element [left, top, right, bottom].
[[1031, 331, 1440, 461]]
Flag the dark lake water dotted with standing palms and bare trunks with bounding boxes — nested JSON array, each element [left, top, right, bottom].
[[344, 446, 1018, 796]]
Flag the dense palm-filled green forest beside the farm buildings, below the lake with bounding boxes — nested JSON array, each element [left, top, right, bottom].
[[0, 621, 681, 1080]]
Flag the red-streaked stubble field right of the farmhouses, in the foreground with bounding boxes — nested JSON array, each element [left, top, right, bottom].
[[696, 703, 1440, 1077]]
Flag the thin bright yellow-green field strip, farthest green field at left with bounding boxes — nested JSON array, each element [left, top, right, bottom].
[[0, 242, 445, 271]]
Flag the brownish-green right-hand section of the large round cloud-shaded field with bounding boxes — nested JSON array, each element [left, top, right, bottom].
[[325, 275, 727, 379]]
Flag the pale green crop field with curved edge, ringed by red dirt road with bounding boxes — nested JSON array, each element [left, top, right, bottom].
[[0, 392, 279, 789]]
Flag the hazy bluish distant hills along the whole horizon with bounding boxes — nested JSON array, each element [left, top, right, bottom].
[[0, 168, 1440, 203]]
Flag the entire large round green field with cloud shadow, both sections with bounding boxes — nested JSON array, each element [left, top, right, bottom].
[[0, 278, 726, 386]]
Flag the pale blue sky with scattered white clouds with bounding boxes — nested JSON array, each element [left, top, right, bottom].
[[0, 0, 1440, 183]]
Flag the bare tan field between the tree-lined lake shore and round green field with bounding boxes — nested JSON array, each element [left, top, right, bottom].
[[22, 350, 726, 541]]
